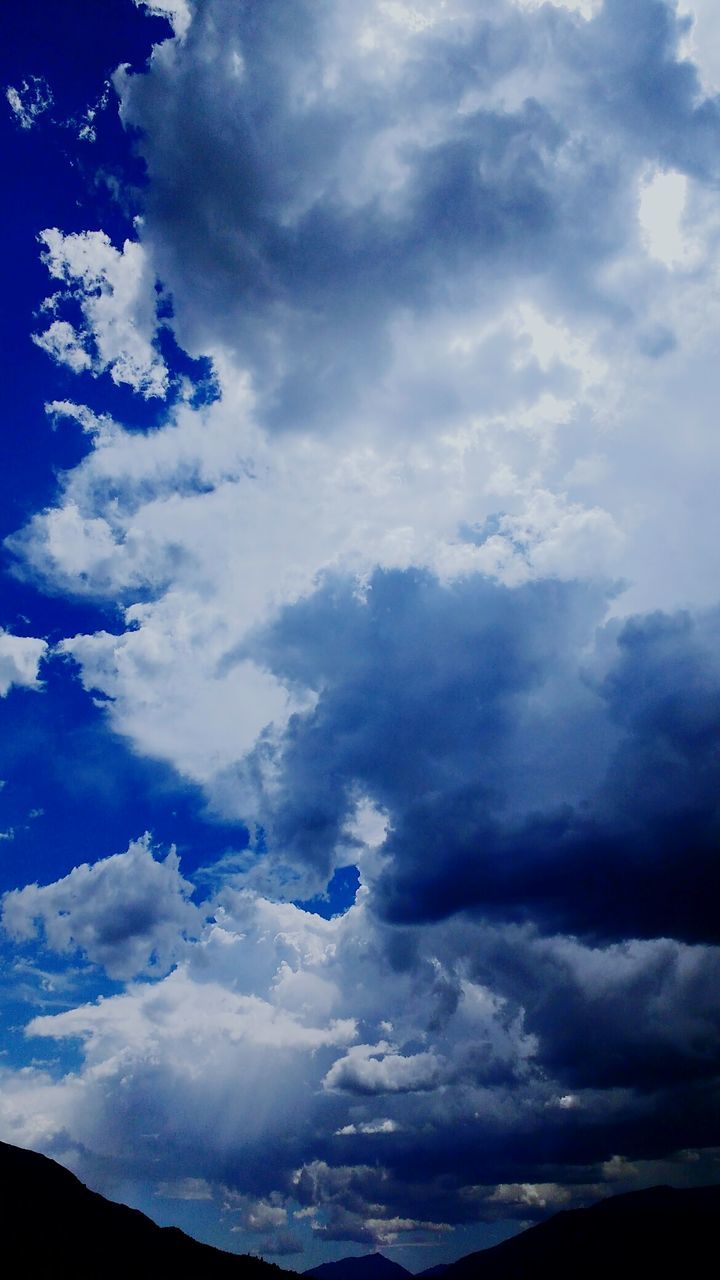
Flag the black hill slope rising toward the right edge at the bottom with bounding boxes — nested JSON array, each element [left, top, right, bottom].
[[435, 1187, 720, 1280]]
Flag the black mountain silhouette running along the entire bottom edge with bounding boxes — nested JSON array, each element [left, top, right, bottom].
[[0, 1142, 720, 1280]]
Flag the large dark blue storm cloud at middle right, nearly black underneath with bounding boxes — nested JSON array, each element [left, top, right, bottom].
[[240, 572, 720, 942]]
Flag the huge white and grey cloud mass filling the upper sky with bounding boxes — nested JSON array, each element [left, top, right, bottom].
[[10, 0, 720, 824]]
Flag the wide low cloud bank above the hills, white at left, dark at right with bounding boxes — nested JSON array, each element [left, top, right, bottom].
[[0, 864, 720, 1228]]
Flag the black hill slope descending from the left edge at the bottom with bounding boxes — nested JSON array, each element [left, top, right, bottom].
[[0, 1142, 297, 1280]]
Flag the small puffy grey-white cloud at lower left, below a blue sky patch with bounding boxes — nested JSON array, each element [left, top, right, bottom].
[[3, 838, 202, 978]]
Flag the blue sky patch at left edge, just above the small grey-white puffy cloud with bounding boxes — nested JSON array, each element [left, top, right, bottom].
[[0, 660, 249, 891]]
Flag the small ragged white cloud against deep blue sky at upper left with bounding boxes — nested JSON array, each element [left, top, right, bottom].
[[33, 227, 168, 398]]
